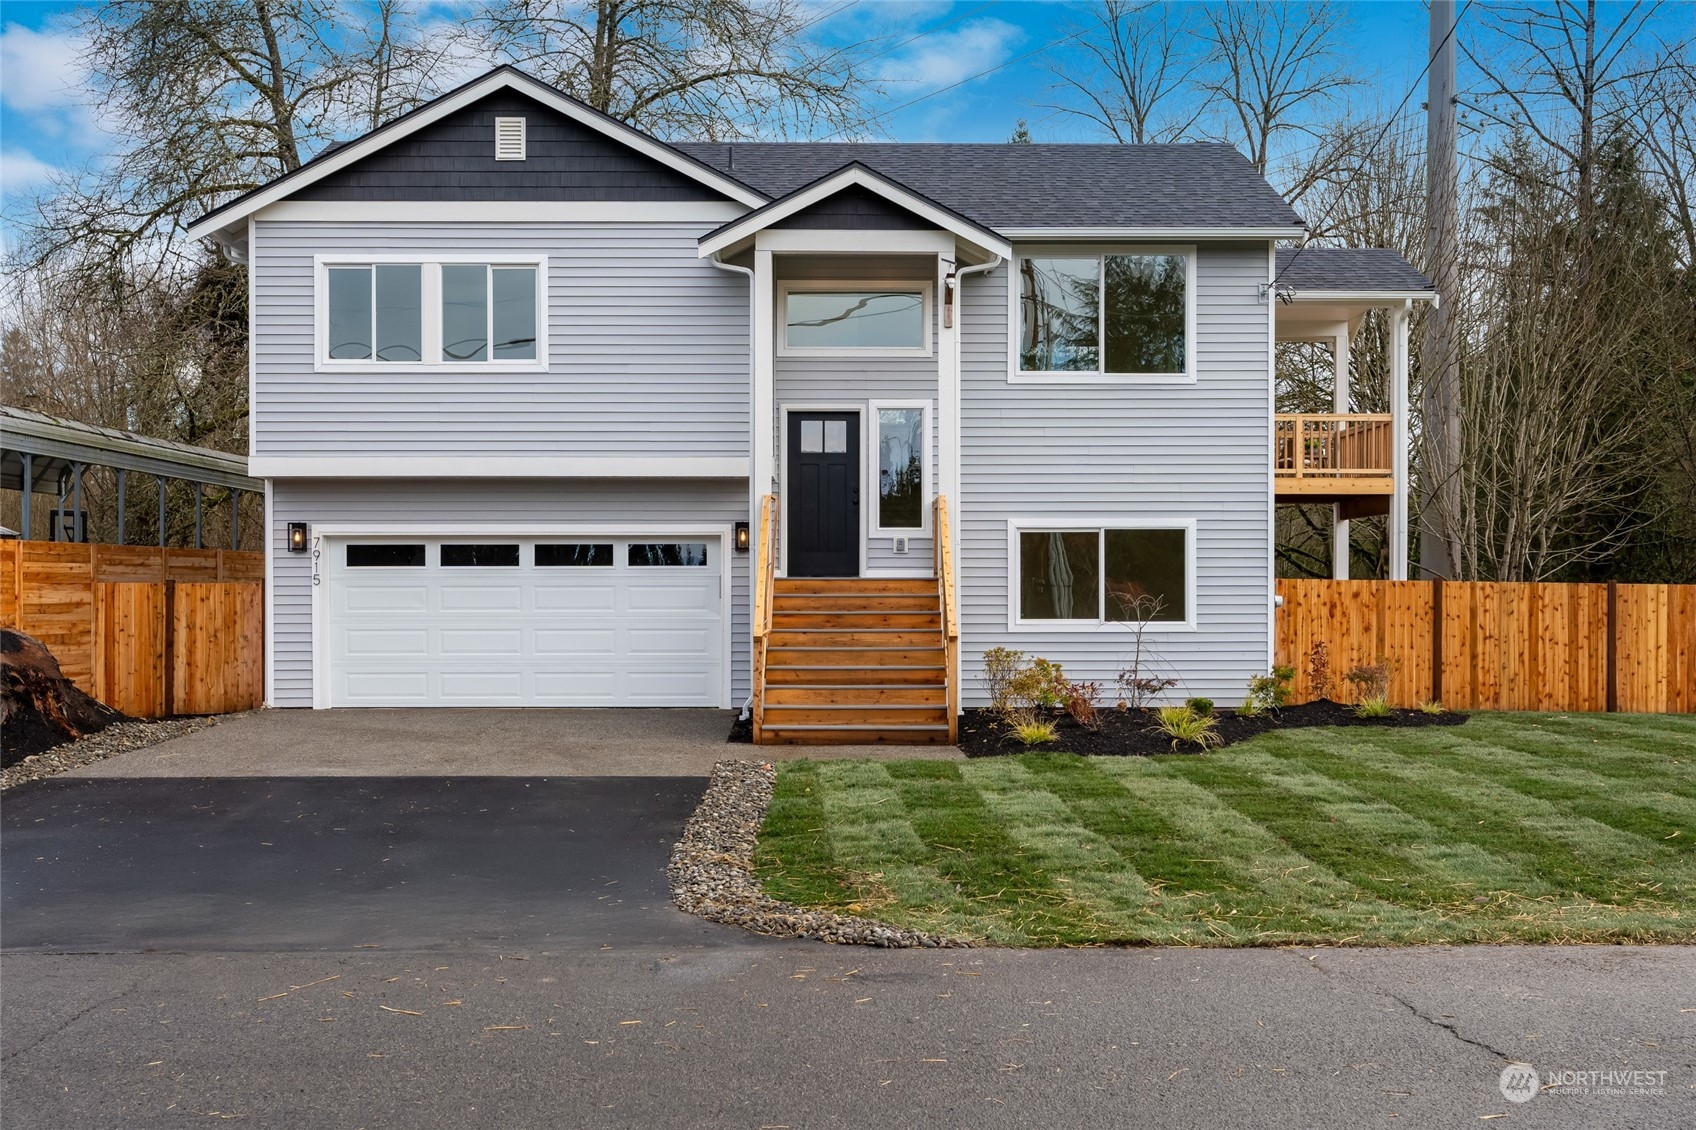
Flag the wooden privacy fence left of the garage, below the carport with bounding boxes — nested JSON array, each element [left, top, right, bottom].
[[0, 541, 265, 718]]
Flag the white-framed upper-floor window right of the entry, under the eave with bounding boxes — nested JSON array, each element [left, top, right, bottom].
[[1009, 246, 1196, 383]]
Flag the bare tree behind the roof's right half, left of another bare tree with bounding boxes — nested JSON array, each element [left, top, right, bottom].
[[1052, 0, 1211, 146]]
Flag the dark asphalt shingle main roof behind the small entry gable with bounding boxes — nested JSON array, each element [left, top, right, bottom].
[[675, 141, 1301, 229]]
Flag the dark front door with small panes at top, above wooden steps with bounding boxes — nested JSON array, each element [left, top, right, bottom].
[[784, 412, 860, 577]]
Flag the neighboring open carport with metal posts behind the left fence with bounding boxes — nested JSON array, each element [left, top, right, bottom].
[[0, 406, 265, 548]]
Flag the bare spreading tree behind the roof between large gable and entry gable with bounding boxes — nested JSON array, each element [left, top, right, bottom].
[[471, 0, 870, 141]]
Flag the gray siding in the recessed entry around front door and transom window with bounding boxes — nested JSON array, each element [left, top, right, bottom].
[[772, 255, 938, 572]]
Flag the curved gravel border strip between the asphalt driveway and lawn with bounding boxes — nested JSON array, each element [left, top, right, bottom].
[[665, 760, 972, 948]]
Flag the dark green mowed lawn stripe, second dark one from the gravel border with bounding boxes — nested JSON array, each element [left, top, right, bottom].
[[885, 762, 1080, 943]]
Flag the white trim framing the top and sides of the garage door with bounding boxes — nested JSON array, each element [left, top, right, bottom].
[[309, 523, 736, 711]]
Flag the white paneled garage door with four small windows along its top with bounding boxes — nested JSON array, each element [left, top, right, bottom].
[[324, 536, 726, 706]]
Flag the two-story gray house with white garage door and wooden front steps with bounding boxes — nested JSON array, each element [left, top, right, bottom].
[[190, 68, 1431, 740]]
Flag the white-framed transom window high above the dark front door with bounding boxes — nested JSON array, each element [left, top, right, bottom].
[[777, 280, 931, 356]]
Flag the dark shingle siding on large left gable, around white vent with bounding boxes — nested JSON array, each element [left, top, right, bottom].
[[293, 92, 724, 200]]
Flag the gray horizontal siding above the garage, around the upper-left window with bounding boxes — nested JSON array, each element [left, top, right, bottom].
[[251, 221, 748, 456]]
